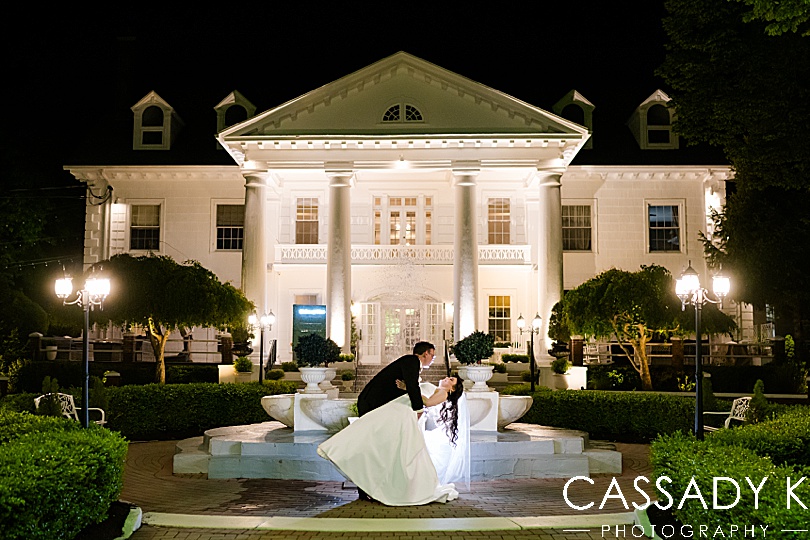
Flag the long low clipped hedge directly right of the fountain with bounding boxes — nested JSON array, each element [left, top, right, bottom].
[[503, 385, 695, 443]]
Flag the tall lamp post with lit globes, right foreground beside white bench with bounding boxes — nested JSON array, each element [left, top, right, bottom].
[[675, 261, 731, 441]]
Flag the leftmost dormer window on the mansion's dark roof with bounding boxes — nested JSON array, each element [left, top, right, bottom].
[[132, 91, 183, 150]]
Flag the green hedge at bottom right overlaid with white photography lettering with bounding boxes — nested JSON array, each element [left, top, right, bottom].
[[651, 429, 810, 538]]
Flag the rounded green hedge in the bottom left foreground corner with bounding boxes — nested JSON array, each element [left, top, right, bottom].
[[0, 411, 127, 540]]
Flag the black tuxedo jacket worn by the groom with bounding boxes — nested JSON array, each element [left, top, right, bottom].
[[357, 354, 424, 416]]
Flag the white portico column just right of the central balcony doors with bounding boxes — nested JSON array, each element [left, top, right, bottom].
[[453, 170, 479, 341]]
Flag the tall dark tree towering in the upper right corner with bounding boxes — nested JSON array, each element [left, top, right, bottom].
[[659, 0, 810, 360]]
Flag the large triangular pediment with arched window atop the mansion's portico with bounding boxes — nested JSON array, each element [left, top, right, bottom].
[[220, 52, 587, 140]]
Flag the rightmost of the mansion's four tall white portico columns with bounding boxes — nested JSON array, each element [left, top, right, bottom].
[[535, 169, 563, 358]]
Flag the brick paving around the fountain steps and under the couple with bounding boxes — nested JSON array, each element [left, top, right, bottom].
[[121, 441, 652, 540]]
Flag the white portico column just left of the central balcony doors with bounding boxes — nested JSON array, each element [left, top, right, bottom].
[[326, 170, 354, 354]]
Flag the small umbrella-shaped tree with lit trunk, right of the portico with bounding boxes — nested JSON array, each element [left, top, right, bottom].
[[549, 265, 734, 390]]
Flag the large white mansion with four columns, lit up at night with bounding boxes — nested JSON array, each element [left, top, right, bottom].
[[66, 52, 740, 363]]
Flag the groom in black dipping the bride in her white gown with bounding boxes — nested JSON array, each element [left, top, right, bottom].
[[318, 341, 470, 506]]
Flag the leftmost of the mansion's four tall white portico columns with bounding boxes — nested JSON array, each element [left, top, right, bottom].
[[242, 172, 267, 313]]
